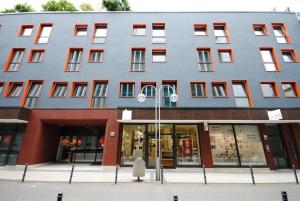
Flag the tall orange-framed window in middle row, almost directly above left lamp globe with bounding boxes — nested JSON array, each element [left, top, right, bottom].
[[131, 48, 145, 72]]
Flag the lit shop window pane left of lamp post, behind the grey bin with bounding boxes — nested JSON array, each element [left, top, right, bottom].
[[121, 125, 146, 165]]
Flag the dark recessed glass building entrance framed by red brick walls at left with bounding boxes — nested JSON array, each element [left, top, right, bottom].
[[56, 127, 105, 164]]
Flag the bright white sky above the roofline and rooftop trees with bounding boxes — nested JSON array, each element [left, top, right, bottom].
[[0, 0, 300, 12]]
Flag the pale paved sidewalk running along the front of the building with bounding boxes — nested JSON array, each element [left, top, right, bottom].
[[0, 164, 299, 184]]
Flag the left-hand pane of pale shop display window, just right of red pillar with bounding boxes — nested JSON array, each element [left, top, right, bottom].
[[209, 125, 239, 166]]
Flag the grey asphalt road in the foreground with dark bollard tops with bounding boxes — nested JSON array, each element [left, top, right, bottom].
[[0, 180, 300, 201]]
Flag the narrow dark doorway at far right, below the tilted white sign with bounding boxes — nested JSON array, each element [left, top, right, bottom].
[[266, 125, 289, 169]]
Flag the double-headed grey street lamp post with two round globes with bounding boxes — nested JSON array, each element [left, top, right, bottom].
[[138, 85, 178, 181]]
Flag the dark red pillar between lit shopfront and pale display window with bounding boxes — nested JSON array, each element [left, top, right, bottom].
[[199, 124, 213, 168]]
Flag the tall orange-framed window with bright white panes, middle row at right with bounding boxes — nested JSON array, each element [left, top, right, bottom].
[[260, 48, 279, 71]]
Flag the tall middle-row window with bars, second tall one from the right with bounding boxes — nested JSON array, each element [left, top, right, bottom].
[[197, 48, 213, 72]]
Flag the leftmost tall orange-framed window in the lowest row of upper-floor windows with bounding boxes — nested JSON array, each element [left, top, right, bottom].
[[24, 81, 43, 108]]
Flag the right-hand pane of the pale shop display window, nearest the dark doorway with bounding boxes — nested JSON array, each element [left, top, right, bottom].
[[234, 125, 267, 165]]
